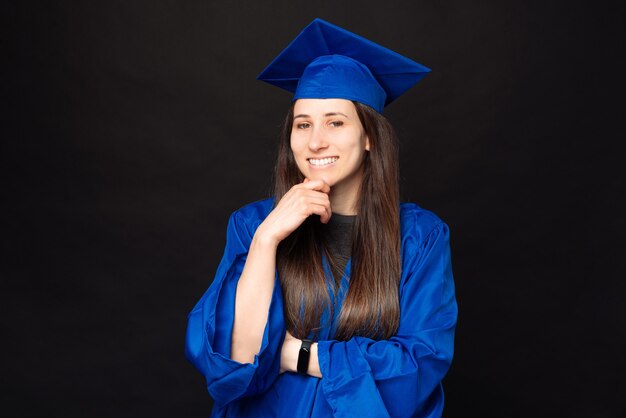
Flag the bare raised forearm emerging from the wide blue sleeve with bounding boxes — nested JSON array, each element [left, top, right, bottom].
[[231, 228, 277, 363]]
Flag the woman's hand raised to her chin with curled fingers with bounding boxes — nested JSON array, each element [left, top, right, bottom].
[[256, 179, 332, 245]]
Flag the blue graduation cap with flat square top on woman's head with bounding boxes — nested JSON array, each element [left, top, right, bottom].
[[257, 19, 430, 112]]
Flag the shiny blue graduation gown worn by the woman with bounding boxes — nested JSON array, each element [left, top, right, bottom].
[[186, 199, 457, 418]]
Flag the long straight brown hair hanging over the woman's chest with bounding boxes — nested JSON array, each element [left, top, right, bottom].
[[274, 102, 400, 340]]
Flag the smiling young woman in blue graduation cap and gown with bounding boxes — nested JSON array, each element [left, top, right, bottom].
[[186, 19, 457, 417]]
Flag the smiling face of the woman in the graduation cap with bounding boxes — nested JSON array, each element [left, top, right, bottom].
[[291, 99, 369, 196]]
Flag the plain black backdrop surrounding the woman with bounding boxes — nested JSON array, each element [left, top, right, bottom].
[[0, 0, 626, 417]]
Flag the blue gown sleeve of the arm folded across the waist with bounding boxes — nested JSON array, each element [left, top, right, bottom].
[[318, 221, 457, 417]]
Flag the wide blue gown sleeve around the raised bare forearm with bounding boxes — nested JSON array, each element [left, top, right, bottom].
[[185, 211, 285, 407]]
